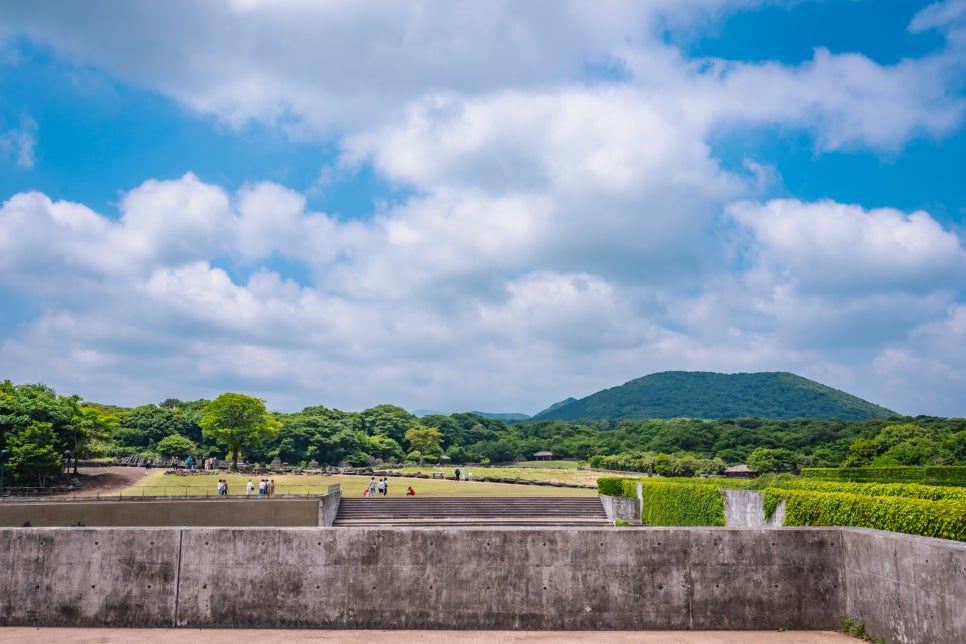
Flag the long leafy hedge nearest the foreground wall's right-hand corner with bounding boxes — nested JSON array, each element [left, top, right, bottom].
[[762, 488, 966, 541]]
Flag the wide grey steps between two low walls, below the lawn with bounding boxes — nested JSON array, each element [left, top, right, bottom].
[[333, 497, 611, 527]]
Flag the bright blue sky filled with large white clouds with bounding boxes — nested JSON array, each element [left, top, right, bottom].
[[0, 0, 966, 417]]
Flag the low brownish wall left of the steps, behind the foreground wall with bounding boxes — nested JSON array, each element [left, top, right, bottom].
[[0, 497, 322, 528]]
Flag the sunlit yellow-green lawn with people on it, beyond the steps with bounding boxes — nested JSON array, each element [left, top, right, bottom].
[[120, 467, 597, 497]]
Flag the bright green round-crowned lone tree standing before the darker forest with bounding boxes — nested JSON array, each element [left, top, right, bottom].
[[201, 393, 281, 470]]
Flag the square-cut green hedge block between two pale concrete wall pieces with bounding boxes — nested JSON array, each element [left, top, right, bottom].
[[641, 479, 725, 526]]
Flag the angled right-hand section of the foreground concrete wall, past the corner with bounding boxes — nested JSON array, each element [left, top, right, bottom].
[[843, 528, 966, 644]]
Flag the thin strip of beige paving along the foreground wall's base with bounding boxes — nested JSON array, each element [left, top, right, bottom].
[[0, 627, 858, 644]]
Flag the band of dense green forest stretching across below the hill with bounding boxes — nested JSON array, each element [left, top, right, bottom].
[[0, 381, 966, 485]]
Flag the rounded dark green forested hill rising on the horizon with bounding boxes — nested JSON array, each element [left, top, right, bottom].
[[532, 371, 898, 421]]
